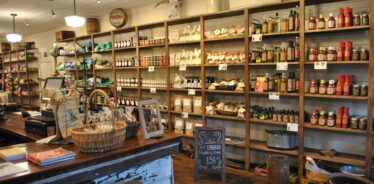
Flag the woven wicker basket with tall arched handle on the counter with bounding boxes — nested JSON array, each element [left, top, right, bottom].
[[72, 89, 127, 152]]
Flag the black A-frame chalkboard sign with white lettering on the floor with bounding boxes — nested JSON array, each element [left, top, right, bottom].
[[195, 127, 226, 182]]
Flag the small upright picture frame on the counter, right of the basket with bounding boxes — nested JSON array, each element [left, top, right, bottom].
[[138, 99, 164, 139]]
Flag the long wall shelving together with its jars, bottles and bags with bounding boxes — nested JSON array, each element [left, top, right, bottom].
[[54, 0, 373, 177]]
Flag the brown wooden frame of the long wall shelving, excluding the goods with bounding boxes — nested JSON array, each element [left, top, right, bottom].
[[54, 0, 374, 178]]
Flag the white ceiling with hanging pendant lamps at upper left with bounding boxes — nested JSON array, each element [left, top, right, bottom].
[[0, 0, 160, 40]]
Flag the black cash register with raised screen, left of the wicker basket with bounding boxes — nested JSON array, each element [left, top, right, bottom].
[[25, 77, 65, 137]]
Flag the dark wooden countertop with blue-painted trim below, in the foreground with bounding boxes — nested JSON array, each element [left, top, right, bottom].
[[0, 130, 181, 184]]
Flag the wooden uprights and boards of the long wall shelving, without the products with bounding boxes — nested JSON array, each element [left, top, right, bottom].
[[54, 0, 374, 181]]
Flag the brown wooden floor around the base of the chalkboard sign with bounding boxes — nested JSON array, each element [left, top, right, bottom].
[[173, 153, 267, 184]]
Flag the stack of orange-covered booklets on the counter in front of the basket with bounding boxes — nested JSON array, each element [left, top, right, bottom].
[[27, 147, 76, 166]]
